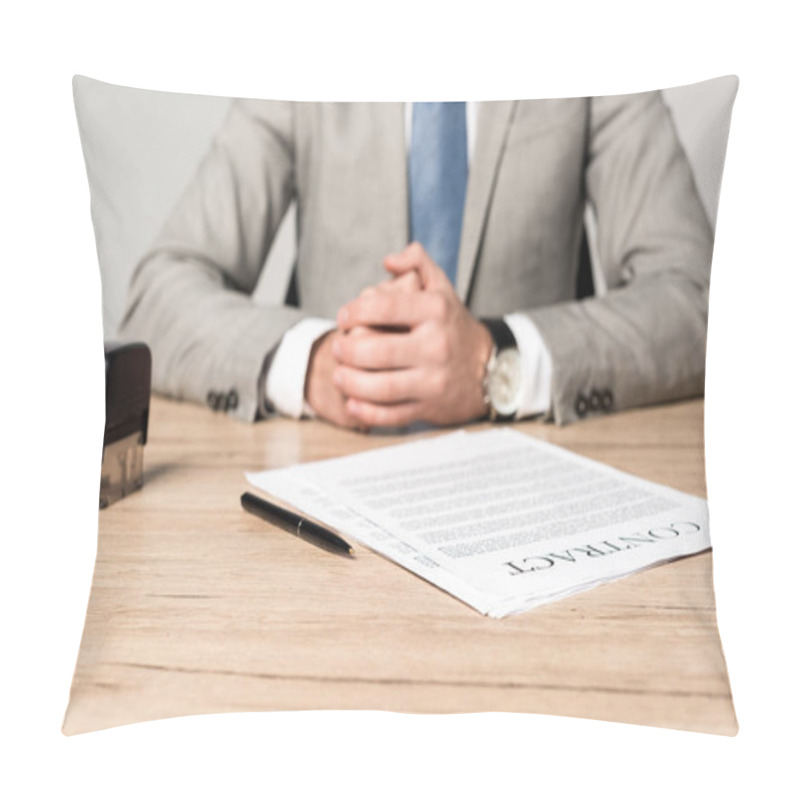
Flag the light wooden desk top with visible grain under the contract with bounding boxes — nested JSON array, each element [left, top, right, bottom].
[[64, 398, 737, 734]]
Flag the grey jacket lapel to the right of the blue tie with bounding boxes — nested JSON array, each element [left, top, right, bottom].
[[456, 100, 516, 302]]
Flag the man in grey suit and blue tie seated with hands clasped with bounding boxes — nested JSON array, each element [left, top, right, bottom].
[[121, 92, 712, 428]]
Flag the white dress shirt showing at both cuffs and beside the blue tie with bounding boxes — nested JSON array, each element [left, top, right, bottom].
[[265, 102, 553, 419]]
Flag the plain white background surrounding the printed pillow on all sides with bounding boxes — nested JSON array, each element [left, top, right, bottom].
[[0, 0, 800, 798]]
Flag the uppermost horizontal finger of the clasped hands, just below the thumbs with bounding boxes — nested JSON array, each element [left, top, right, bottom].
[[336, 291, 448, 331]]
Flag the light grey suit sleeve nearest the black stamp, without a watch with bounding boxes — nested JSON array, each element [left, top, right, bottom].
[[120, 100, 302, 420]]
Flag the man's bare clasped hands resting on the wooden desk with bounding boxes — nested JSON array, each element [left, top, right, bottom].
[[305, 242, 493, 430]]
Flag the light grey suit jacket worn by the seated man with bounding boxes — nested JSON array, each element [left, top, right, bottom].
[[121, 93, 712, 423]]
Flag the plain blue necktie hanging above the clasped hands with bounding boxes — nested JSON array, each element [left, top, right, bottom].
[[408, 103, 468, 283]]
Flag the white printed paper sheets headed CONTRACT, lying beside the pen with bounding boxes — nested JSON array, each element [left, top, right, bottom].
[[247, 429, 710, 617]]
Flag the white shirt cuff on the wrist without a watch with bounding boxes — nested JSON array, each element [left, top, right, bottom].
[[265, 317, 336, 419]]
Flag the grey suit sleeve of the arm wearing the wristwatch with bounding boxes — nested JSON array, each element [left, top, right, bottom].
[[529, 92, 713, 424]]
